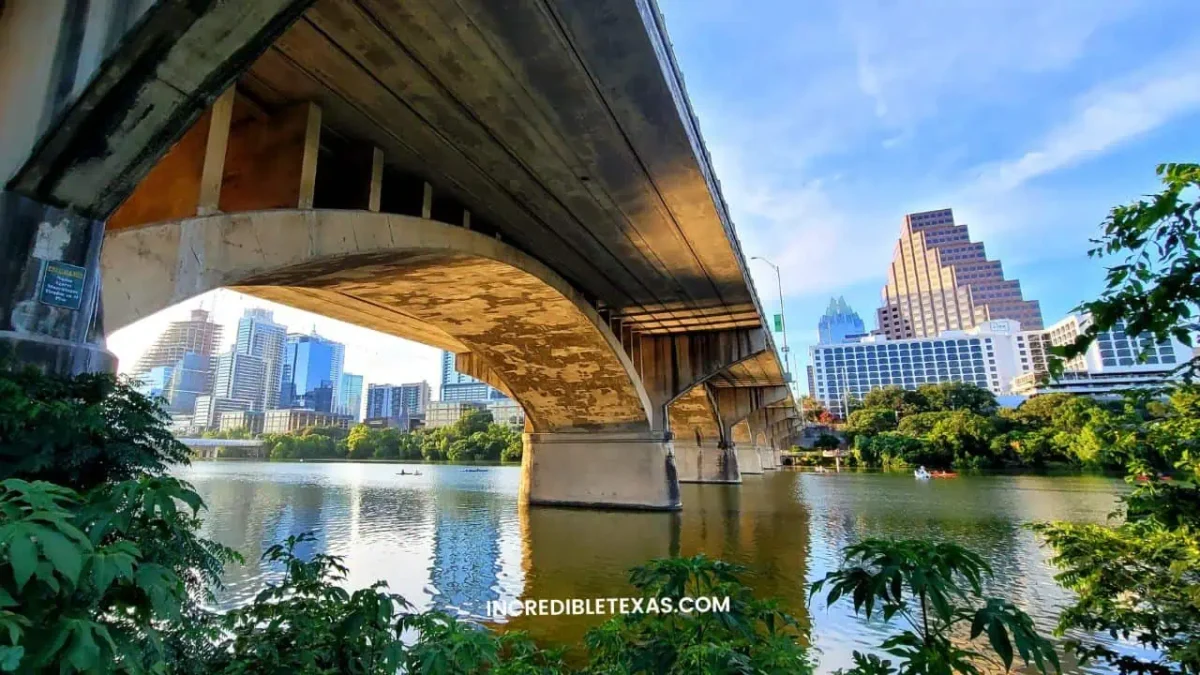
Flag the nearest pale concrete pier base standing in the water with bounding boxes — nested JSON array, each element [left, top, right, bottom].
[[518, 431, 680, 510]]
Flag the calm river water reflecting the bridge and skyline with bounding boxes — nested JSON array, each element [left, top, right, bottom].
[[180, 461, 1124, 673]]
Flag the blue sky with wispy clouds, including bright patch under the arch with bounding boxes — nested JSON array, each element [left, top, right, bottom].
[[109, 0, 1200, 393]]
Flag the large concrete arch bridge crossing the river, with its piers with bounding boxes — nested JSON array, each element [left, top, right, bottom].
[[7, 0, 797, 509]]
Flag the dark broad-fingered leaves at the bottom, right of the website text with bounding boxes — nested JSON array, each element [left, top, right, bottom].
[[810, 539, 1061, 675]]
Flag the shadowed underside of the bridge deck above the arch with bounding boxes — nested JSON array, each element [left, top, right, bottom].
[[228, 0, 762, 333]]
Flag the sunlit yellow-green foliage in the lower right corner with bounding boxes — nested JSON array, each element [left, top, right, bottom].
[[1036, 384, 1200, 675]]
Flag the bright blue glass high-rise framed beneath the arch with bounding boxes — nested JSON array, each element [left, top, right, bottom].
[[280, 333, 346, 412]]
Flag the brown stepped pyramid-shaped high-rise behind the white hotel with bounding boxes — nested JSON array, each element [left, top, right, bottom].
[[877, 209, 1043, 340]]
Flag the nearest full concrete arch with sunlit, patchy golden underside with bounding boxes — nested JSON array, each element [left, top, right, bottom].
[[101, 209, 652, 434]]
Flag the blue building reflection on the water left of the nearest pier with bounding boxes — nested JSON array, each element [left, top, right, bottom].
[[430, 490, 500, 617]]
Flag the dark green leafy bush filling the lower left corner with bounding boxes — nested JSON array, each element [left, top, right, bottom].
[[0, 371, 235, 674]]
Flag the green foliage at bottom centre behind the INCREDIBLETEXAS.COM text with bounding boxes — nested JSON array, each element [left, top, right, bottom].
[[584, 555, 812, 675]]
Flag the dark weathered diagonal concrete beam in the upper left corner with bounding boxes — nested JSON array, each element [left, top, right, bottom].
[[8, 0, 311, 219]]
